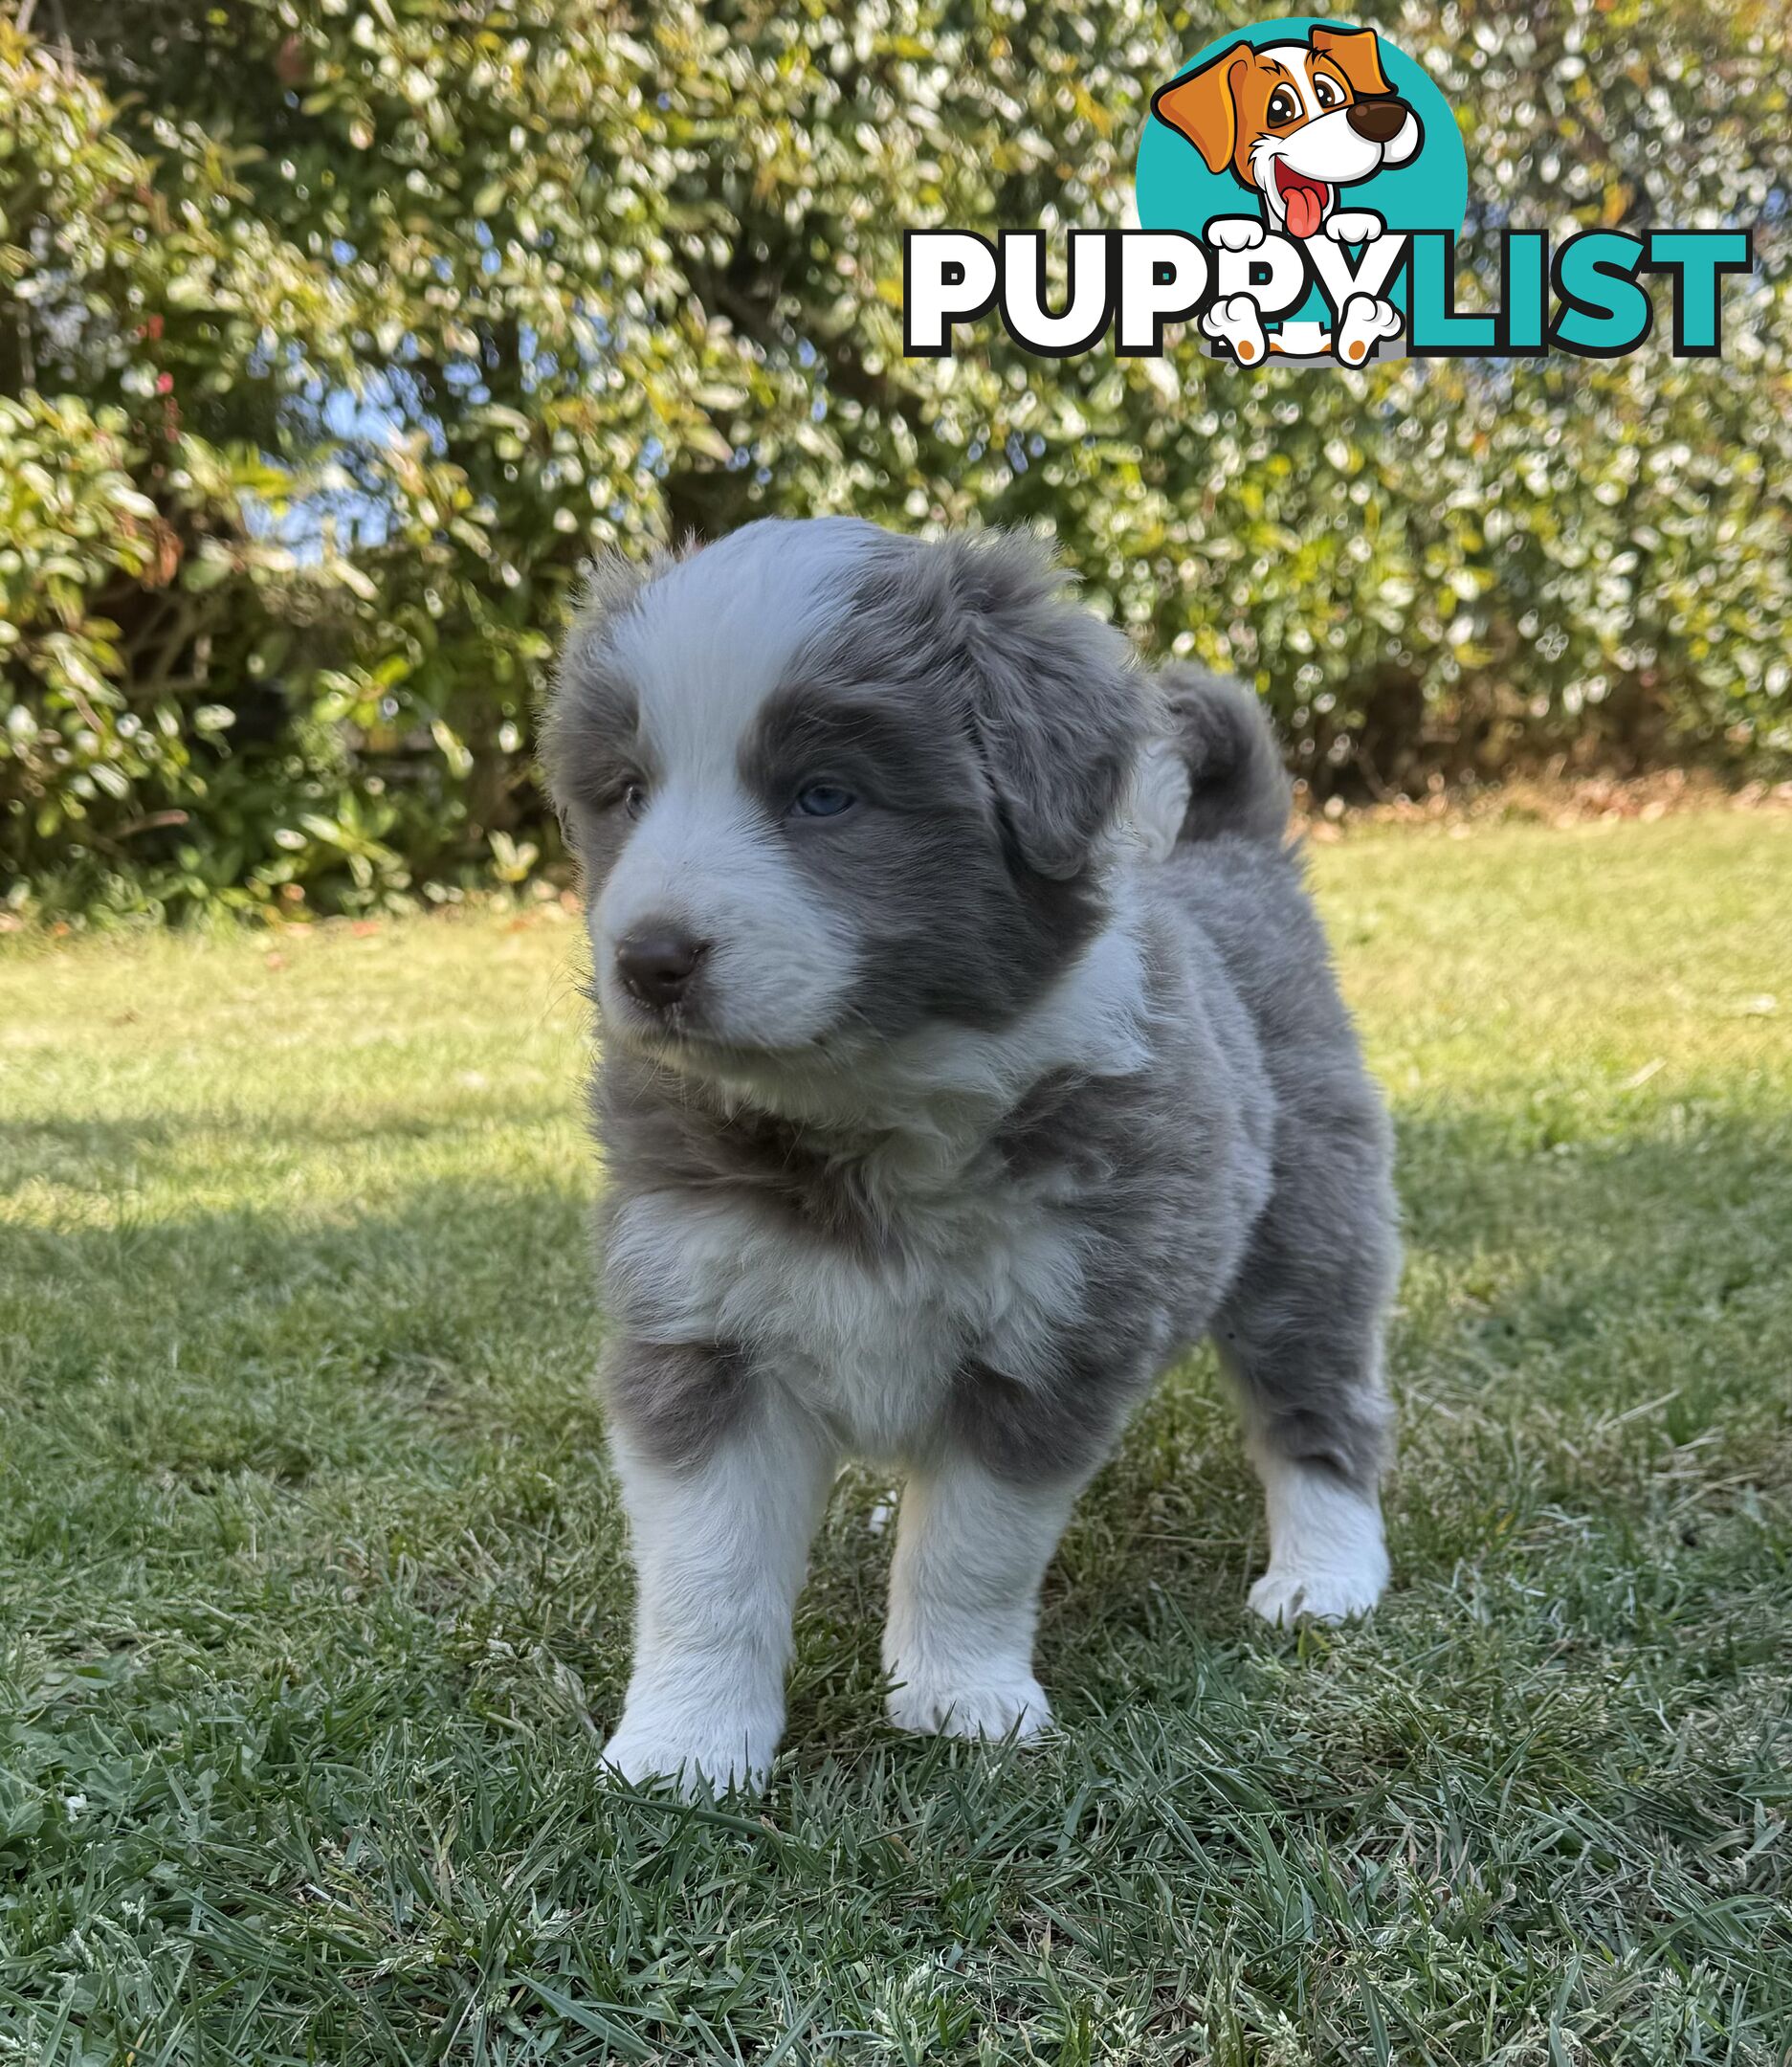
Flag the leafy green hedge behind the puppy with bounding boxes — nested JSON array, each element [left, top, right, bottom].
[[0, 0, 1792, 916]]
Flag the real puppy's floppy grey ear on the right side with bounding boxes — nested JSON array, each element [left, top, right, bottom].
[[934, 531, 1145, 880]]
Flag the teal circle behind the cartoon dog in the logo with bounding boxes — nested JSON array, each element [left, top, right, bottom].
[[1135, 14, 1468, 326]]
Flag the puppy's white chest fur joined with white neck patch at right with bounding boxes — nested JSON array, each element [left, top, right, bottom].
[[608, 900, 1147, 1457]]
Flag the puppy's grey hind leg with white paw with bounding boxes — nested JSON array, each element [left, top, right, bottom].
[[1213, 1157, 1400, 1623]]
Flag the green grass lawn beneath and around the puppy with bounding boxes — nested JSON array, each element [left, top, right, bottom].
[[0, 814, 1792, 2067]]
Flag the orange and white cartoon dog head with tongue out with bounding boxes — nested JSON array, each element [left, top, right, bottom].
[[1151, 29, 1422, 237]]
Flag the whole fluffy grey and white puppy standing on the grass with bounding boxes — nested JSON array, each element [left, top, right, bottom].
[[543, 519, 1400, 1786]]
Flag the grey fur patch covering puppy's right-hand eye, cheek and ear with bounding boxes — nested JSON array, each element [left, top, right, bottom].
[[746, 533, 1145, 1035]]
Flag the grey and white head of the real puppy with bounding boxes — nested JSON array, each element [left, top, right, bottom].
[[543, 519, 1143, 1073]]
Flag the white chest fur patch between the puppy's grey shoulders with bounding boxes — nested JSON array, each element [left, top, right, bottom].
[[608, 1176, 1083, 1457]]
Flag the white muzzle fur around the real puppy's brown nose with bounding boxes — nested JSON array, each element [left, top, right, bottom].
[[591, 775, 858, 1048]]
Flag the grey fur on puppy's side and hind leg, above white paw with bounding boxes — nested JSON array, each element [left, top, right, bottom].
[[953, 841, 1400, 1490]]
